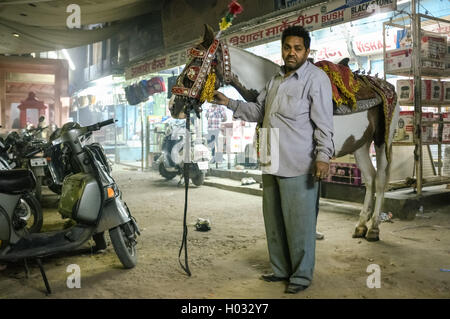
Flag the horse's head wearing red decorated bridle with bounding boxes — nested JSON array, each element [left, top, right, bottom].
[[169, 25, 231, 119]]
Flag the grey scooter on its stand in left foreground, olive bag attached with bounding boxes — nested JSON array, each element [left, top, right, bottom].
[[0, 119, 140, 294]]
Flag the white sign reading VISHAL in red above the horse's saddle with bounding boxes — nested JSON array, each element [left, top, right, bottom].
[[352, 33, 396, 56]]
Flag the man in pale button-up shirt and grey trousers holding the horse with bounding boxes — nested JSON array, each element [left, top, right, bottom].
[[214, 26, 334, 293]]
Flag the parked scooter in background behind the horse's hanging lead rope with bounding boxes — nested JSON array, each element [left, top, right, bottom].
[[154, 121, 211, 186]]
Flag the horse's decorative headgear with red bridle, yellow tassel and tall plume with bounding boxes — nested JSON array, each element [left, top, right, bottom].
[[172, 0, 242, 110]]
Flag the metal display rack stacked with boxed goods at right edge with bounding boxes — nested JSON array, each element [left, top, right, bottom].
[[383, 10, 450, 195]]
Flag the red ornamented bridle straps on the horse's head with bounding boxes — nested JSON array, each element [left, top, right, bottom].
[[172, 39, 231, 99]]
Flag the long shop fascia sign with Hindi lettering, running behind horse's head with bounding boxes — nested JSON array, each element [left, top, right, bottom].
[[125, 0, 397, 80]]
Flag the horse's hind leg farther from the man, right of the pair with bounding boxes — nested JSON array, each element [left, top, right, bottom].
[[366, 144, 390, 241]]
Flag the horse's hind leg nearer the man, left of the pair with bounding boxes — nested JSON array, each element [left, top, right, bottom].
[[353, 142, 376, 238]]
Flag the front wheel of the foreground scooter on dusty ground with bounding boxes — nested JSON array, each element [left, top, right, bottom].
[[109, 223, 137, 269]]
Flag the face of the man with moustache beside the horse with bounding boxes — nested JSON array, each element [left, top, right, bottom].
[[281, 36, 309, 72]]
